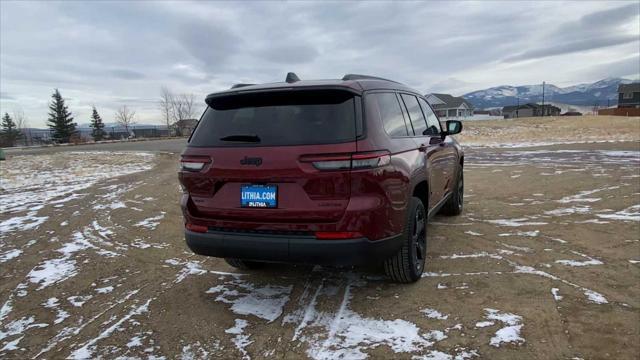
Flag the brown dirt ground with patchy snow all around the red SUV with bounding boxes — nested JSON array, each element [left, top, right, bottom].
[[0, 132, 640, 359]]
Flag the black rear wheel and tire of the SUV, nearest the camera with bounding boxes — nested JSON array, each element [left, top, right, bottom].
[[384, 197, 427, 283]]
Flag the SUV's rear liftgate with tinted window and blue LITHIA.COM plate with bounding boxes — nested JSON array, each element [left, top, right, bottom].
[[180, 90, 362, 223]]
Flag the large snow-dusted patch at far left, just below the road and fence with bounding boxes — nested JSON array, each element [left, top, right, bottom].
[[0, 152, 155, 239]]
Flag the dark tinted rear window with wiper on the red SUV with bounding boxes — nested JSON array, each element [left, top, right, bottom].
[[189, 90, 356, 147]]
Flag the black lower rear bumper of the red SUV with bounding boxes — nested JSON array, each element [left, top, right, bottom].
[[185, 230, 401, 265]]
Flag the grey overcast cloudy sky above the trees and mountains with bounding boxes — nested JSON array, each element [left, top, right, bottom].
[[0, 0, 640, 127]]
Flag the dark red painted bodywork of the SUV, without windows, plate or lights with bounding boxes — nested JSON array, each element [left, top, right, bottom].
[[179, 82, 462, 246]]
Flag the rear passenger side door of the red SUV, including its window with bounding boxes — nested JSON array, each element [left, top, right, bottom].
[[401, 94, 444, 209]]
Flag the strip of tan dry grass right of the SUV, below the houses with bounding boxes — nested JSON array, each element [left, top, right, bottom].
[[457, 115, 640, 145]]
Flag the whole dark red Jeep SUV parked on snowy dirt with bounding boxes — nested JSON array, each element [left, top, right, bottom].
[[179, 73, 464, 283]]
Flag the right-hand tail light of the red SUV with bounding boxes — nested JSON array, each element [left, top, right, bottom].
[[300, 151, 391, 170]]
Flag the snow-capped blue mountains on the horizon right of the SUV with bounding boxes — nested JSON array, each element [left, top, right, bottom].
[[463, 78, 633, 109]]
